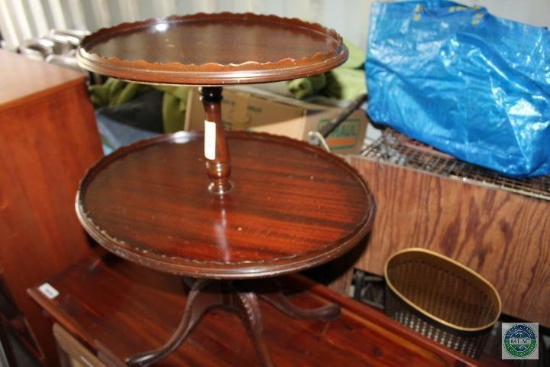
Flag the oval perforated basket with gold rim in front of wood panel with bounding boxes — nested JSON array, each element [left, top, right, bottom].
[[384, 248, 501, 359]]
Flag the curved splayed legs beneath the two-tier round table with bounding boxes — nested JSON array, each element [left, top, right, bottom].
[[126, 279, 340, 367]]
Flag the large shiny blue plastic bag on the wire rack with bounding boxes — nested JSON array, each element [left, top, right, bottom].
[[365, 1, 550, 177]]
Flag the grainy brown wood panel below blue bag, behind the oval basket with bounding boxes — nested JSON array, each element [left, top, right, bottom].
[[349, 157, 550, 325]]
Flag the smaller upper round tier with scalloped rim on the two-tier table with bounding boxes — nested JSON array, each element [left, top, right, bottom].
[[77, 13, 348, 86]]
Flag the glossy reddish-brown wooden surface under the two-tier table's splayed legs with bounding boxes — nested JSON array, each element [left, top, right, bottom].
[[30, 260, 504, 367]]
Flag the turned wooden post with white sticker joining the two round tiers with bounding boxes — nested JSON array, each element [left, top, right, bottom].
[[199, 87, 231, 195]]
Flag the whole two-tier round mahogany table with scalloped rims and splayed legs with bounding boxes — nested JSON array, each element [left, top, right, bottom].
[[76, 13, 375, 366]]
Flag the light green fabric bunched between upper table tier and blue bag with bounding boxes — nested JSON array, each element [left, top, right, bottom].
[[287, 41, 367, 101]]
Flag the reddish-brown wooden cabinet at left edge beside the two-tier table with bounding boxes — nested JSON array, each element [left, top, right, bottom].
[[0, 50, 102, 366]]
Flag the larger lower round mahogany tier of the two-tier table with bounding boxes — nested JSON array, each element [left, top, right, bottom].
[[76, 131, 375, 279]]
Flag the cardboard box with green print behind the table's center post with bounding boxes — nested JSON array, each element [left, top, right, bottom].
[[185, 88, 368, 154]]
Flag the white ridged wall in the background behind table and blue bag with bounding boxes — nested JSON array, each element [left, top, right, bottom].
[[0, 0, 550, 49]]
